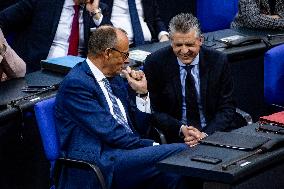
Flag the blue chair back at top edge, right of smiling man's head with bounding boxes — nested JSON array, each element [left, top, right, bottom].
[[196, 0, 238, 32]]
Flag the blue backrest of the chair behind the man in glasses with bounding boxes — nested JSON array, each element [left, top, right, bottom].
[[34, 97, 59, 162]]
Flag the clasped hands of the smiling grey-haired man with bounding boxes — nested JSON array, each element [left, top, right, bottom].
[[181, 125, 207, 147]]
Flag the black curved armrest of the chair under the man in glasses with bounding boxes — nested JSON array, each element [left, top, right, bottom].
[[54, 158, 107, 189]]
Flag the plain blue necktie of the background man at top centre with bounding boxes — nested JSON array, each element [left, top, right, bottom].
[[128, 0, 144, 46]]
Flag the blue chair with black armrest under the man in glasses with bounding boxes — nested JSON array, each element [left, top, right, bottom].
[[34, 97, 106, 189]]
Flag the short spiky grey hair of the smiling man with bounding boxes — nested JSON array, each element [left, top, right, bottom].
[[169, 13, 201, 36]]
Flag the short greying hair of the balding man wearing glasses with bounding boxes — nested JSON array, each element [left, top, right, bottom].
[[88, 26, 117, 54]]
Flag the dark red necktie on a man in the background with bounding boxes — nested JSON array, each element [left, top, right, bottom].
[[68, 5, 80, 56]]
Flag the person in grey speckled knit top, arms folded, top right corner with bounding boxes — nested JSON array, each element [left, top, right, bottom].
[[231, 0, 284, 30]]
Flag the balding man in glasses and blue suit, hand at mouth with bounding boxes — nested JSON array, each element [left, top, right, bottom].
[[55, 26, 193, 189]]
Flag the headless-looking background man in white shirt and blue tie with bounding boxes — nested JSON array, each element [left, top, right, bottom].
[[102, 0, 169, 46]]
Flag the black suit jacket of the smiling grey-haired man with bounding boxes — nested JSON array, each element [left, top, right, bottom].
[[144, 46, 235, 141]]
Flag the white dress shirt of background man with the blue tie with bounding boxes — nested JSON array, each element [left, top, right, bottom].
[[111, 0, 168, 44]]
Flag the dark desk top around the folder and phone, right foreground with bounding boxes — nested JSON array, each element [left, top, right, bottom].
[[158, 124, 284, 183]]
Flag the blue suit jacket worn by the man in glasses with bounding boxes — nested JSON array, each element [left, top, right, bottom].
[[55, 62, 154, 189]]
